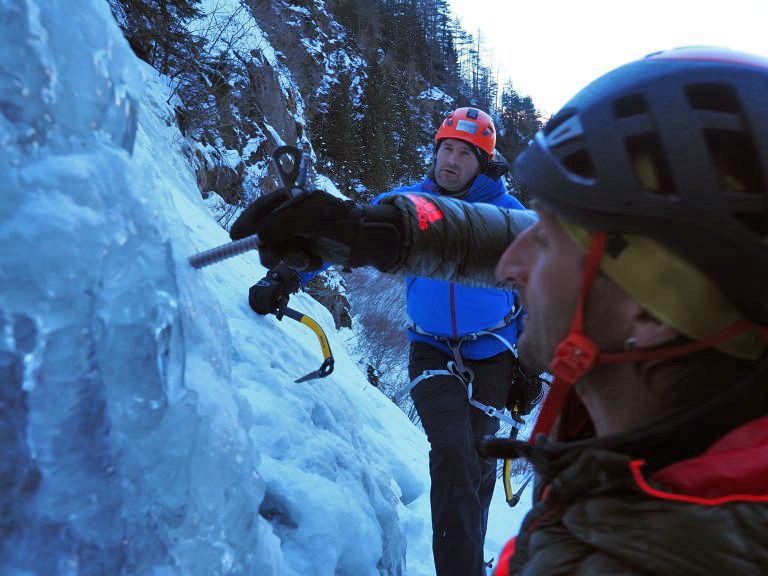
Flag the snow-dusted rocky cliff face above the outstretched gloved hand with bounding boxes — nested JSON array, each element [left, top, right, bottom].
[[164, 0, 365, 205]]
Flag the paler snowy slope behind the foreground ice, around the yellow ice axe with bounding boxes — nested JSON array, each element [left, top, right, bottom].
[[135, 63, 440, 575]]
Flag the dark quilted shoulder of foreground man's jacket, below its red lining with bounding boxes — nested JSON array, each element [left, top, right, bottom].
[[497, 436, 768, 576]]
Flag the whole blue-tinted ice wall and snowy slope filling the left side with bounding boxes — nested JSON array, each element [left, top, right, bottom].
[[0, 0, 536, 576]]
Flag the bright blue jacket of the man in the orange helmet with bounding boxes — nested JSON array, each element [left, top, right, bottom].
[[372, 174, 523, 360]]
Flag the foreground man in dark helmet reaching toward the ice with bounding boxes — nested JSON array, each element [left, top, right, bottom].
[[231, 48, 768, 576]]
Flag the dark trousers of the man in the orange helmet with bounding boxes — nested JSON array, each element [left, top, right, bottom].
[[409, 342, 514, 576]]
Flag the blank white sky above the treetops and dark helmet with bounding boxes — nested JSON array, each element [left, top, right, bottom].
[[449, 0, 768, 115]]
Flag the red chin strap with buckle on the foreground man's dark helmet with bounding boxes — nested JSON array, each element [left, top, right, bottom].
[[528, 232, 768, 444]]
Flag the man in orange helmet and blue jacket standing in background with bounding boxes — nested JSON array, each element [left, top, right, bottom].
[[243, 107, 540, 576]]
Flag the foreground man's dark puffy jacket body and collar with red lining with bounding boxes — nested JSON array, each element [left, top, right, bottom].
[[496, 361, 768, 576]]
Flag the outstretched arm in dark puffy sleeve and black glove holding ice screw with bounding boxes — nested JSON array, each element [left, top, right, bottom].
[[230, 190, 536, 287]]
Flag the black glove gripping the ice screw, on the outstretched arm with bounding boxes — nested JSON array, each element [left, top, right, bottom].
[[229, 189, 404, 271]]
